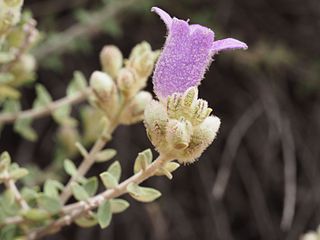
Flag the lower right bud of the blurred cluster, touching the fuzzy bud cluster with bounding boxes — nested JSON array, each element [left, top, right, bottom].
[[120, 91, 152, 125]]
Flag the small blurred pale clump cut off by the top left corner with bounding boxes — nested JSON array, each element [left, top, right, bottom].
[[0, 0, 23, 36]]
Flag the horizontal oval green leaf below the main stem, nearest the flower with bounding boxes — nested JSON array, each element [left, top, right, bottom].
[[127, 183, 161, 202]]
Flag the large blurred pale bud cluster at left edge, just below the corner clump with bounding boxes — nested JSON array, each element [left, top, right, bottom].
[[0, 8, 39, 101]]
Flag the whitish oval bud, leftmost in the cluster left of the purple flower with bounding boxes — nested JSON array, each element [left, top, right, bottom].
[[90, 71, 119, 118]]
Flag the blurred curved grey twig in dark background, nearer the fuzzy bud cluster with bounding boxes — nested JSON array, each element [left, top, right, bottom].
[[212, 103, 262, 199]]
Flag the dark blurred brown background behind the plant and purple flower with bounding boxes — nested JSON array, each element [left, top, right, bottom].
[[0, 0, 320, 240]]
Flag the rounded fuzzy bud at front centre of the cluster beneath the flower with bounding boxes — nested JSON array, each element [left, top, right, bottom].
[[166, 118, 192, 150]]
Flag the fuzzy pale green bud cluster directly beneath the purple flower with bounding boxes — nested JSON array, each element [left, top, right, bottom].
[[144, 87, 220, 163]]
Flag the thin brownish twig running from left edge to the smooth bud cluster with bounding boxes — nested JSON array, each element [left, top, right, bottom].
[[0, 89, 91, 124]]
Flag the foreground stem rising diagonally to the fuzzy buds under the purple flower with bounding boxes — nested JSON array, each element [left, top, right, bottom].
[[28, 154, 173, 240]]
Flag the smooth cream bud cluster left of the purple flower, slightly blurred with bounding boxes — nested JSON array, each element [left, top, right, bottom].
[[90, 42, 159, 125]]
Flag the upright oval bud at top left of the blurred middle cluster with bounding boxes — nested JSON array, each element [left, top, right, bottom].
[[100, 45, 123, 78]]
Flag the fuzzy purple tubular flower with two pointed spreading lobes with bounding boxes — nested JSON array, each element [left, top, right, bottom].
[[151, 7, 247, 98]]
